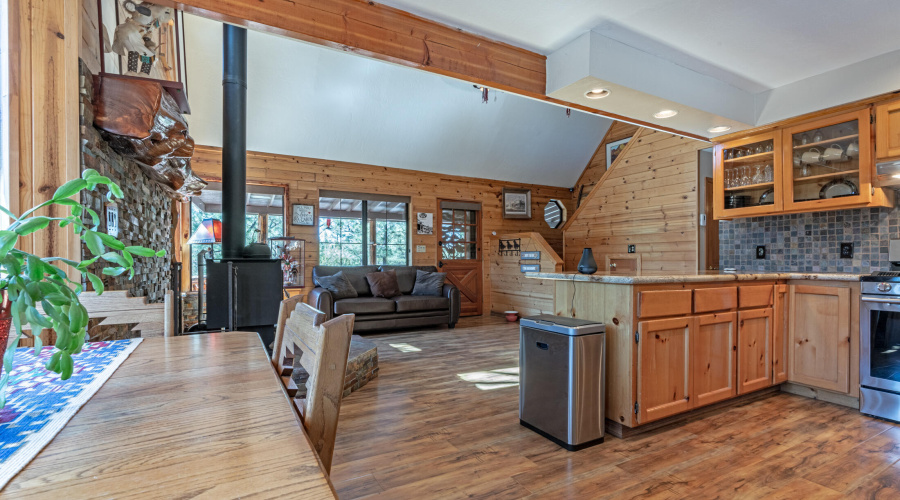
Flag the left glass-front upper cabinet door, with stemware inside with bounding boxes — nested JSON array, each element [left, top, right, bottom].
[[713, 132, 782, 219]]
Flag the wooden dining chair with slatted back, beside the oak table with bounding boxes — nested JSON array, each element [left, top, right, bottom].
[[272, 297, 354, 474]]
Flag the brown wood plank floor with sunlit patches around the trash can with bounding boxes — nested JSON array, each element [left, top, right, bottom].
[[331, 317, 900, 499]]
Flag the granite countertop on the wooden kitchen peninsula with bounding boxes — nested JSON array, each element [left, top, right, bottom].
[[525, 271, 864, 285]]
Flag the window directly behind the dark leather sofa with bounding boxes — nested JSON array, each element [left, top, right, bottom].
[[319, 191, 409, 266]]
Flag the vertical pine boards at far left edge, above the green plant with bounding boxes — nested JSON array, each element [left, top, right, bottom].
[[5, 0, 81, 260]]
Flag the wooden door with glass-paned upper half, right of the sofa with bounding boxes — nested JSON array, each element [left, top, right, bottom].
[[438, 204, 483, 316]]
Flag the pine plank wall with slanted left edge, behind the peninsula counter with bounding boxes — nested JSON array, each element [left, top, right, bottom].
[[564, 128, 711, 271]]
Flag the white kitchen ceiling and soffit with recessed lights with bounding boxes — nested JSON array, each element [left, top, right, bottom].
[[383, 0, 900, 136]]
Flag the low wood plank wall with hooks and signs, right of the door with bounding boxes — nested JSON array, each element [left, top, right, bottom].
[[487, 233, 563, 316]]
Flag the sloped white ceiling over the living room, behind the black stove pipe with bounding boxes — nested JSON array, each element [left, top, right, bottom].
[[184, 15, 611, 187]]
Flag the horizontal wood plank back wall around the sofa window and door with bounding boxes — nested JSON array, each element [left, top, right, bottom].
[[191, 146, 573, 311]]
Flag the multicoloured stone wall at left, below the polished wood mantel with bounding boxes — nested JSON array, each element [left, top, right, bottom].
[[79, 62, 173, 302]]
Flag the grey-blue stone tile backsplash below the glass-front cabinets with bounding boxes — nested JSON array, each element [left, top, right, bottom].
[[719, 208, 900, 273]]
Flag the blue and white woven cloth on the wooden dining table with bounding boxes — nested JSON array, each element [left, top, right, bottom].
[[0, 339, 143, 489]]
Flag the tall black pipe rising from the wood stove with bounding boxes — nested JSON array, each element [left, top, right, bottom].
[[222, 23, 247, 259]]
